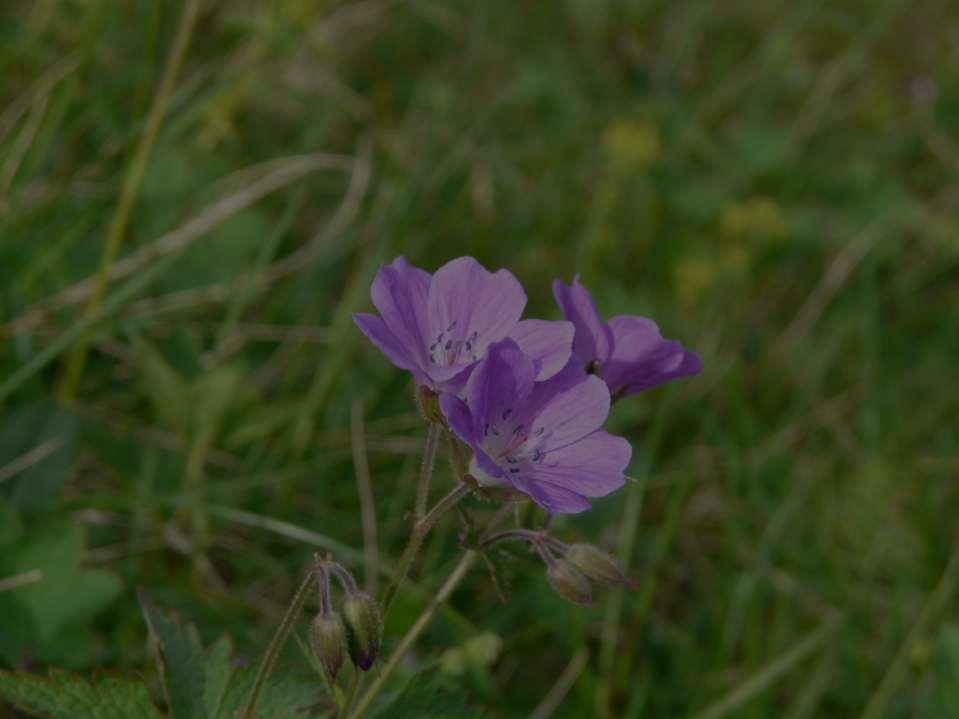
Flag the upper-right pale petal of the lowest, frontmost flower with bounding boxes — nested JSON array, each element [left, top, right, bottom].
[[532, 375, 610, 449]]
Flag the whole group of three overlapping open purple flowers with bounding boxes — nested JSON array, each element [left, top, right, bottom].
[[354, 257, 700, 513]]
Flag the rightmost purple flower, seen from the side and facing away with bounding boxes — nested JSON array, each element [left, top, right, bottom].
[[553, 275, 702, 398]]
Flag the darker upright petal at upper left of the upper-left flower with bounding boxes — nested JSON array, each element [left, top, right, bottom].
[[370, 256, 430, 367]]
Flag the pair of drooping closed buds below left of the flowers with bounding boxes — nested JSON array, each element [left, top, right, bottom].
[[311, 560, 383, 682]]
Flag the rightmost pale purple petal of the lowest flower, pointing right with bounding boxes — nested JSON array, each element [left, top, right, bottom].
[[524, 429, 633, 497]]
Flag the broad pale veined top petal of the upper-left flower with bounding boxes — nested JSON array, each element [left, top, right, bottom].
[[428, 257, 526, 365]]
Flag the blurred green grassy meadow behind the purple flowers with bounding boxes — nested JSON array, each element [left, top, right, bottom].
[[0, 0, 959, 719]]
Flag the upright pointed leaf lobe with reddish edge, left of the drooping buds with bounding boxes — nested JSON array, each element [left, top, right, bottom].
[[137, 589, 207, 719]]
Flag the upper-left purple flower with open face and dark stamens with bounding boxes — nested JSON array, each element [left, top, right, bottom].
[[353, 257, 573, 392]]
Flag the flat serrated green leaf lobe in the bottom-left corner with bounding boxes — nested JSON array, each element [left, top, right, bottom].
[[0, 671, 163, 719]]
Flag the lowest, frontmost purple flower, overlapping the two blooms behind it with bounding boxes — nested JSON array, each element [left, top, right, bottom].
[[440, 339, 632, 514]]
